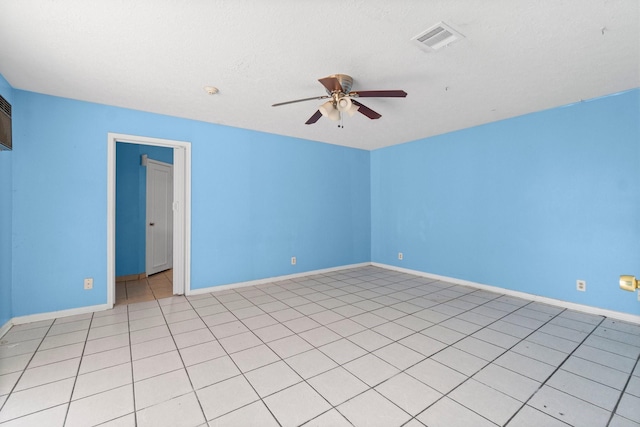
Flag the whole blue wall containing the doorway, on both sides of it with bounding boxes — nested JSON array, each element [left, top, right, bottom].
[[11, 90, 371, 316]]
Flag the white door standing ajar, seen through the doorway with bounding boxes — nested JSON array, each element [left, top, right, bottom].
[[146, 159, 173, 275]]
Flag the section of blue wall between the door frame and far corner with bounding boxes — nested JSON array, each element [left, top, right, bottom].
[[191, 126, 371, 288]]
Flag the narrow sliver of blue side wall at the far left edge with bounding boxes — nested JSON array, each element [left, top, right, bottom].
[[0, 75, 15, 327]]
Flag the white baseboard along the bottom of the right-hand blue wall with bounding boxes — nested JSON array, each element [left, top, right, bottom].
[[371, 262, 640, 324]]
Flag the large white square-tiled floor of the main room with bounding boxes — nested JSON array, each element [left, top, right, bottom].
[[0, 266, 640, 427]]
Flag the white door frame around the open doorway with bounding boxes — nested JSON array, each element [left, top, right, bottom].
[[107, 132, 191, 307]]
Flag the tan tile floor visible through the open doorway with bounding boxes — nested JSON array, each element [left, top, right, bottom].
[[115, 270, 173, 306]]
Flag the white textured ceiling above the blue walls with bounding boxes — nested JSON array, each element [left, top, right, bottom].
[[0, 0, 640, 149]]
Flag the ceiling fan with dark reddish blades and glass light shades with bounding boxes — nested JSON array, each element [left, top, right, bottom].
[[272, 74, 407, 125]]
